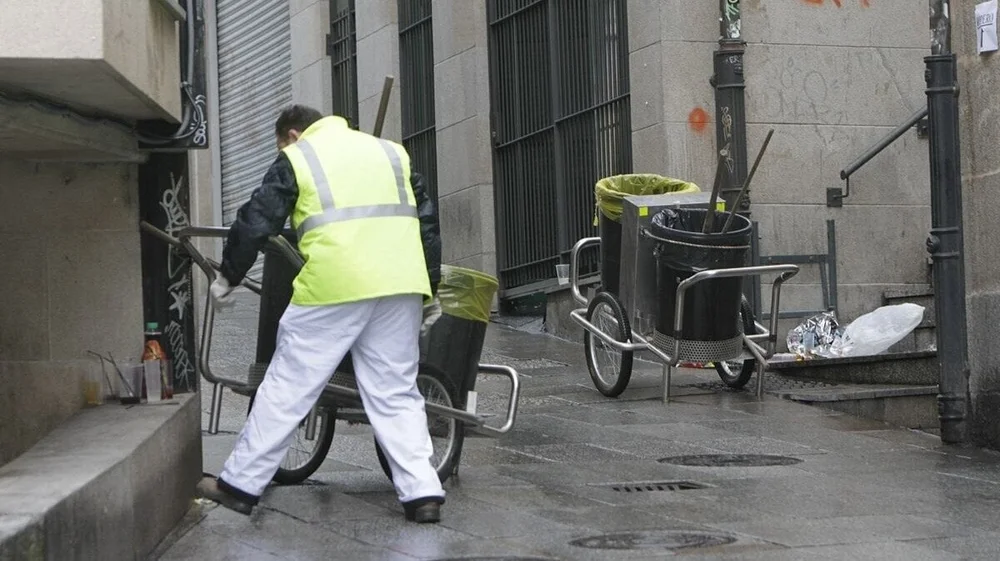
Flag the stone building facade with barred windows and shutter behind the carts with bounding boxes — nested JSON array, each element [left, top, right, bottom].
[[199, 0, 930, 332]]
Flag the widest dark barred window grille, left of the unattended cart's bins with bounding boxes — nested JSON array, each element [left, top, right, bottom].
[[487, 0, 632, 297]]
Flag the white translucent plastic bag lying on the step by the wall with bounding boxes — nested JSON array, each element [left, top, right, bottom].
[[830, 304, 924, 356]]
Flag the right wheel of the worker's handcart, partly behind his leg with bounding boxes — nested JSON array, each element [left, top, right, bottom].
[[375, 364, 465, 483]]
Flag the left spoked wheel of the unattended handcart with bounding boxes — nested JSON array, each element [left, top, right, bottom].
[[583, 292, 632, 397]]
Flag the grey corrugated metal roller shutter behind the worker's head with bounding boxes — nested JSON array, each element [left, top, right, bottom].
[[216, 0, 292, 279]]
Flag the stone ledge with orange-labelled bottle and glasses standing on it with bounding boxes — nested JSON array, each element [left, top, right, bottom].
[[0, 394, 201, 561]]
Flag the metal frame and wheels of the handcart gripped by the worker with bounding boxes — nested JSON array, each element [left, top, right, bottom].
[[141, 222, 521, 484]]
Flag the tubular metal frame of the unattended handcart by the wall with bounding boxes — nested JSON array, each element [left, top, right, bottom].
[[569, 234, 799, 403]]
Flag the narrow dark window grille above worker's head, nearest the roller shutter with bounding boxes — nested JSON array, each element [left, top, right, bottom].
[[327, 0, 360, 128]]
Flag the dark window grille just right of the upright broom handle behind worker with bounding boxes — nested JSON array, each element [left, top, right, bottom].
[[399, 0, 438, 204]]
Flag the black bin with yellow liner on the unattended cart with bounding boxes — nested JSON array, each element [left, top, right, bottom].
[[594, 173, 700, 295]]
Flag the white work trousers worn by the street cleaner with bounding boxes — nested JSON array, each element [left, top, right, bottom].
[[219, 295, 444, 503]]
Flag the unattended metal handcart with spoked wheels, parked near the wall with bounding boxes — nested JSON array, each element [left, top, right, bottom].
[[570, 193, 799, 403]]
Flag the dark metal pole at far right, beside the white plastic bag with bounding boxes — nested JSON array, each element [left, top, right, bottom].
[[924, 0, 969, 444]]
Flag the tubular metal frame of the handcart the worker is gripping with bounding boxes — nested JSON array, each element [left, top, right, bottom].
[[140, 221, 521, 482]]
